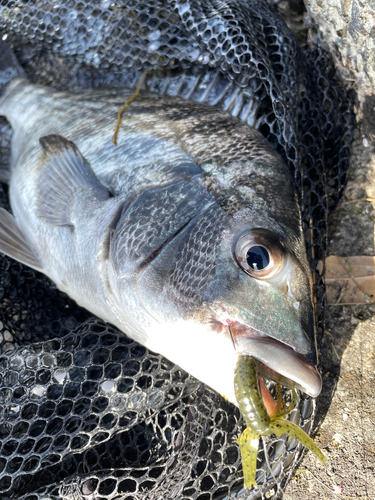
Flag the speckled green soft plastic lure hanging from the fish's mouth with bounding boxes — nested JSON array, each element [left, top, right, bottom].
[[234, 356, 326, 488]]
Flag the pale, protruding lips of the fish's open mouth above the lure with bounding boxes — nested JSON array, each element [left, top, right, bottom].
[[228, 322, 322, 398]]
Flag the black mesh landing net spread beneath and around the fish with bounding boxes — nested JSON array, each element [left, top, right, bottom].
[[0, 0, 353, 500]]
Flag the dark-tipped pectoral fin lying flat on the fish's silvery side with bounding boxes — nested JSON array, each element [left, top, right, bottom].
[[37, 135, 111, 226]]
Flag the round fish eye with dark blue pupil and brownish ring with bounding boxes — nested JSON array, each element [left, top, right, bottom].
[[234, 229, 285, 280]]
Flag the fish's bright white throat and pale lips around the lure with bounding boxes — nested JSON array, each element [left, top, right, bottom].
[[140, 316, 321, 406]]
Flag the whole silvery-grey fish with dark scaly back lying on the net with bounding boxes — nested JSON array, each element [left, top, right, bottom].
[[0, 42, 322, 424]]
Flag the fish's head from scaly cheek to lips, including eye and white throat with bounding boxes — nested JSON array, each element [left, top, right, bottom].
[[129, 189, 321, 402]]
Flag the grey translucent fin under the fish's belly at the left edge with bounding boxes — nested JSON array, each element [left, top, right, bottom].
[[0, 208, 43, 272]]
